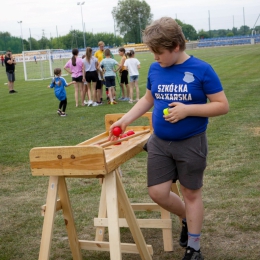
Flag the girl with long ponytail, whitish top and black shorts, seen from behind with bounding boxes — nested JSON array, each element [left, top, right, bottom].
[[83, 47, 98, 106]]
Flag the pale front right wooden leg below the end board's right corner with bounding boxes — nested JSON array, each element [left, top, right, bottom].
[[105, 171, 122, 260]]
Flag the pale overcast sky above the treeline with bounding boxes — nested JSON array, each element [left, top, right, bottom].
[[0, 0, 260, 40]]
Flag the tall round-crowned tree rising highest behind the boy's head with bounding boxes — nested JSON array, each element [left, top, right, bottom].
[[112, 0, 153, 43]]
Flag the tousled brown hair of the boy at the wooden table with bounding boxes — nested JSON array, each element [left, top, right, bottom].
[[143, 17, 186, 53]]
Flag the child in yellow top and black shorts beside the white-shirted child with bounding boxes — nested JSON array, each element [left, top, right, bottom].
[[118, 48, 130, 101]]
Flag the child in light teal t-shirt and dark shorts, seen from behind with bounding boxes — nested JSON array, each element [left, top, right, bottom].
[[98, 49, 119, 105]]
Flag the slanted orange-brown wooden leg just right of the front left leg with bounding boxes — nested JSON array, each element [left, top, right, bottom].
[[59, 177, 82, 260]]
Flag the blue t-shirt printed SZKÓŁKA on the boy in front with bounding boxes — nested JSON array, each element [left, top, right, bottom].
[[147, 56, 223, 141]]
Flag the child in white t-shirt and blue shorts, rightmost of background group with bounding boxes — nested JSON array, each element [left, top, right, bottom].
[[124, 50, 140, 103]]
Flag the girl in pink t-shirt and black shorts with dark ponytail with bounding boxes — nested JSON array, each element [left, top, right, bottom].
[[64, 49, 85, 107]]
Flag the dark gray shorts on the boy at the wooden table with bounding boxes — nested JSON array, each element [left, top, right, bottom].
[[144, 132, 208, 190]]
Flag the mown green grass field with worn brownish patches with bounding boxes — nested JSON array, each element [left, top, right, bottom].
[[0, 44, 260, 260]]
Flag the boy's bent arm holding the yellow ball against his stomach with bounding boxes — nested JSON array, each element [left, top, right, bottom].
[[164, 91, 229, 123]]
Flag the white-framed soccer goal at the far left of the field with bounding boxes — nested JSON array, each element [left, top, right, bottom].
[[23, 49, 71, 81]]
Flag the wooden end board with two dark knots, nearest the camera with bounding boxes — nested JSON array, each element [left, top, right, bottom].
[[30, 146, 107, 176]]
